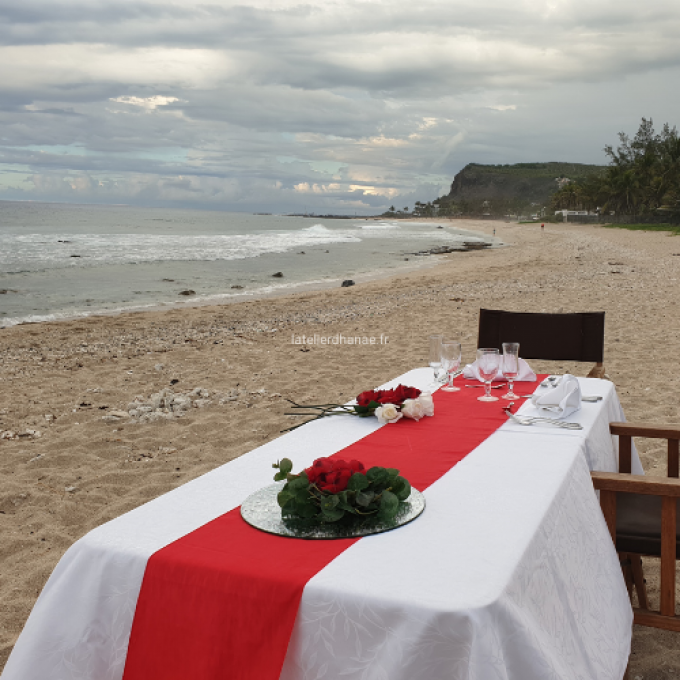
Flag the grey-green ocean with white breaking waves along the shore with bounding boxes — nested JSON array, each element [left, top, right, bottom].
[[0, 201, 488, 328]]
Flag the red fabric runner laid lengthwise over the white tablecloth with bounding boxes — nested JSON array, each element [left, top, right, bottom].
[[123, 378, 540, 680]]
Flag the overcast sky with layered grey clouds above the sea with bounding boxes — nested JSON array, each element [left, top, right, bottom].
[[0, 0, 680, 214]]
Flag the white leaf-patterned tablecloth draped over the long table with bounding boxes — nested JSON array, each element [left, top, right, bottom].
[[2, 369, 641, 680]]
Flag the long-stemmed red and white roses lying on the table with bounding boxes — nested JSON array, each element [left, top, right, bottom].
[[284, 385, 434, 432]]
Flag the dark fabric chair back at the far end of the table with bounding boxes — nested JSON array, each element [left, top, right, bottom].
[[477, 309, 604, 378]]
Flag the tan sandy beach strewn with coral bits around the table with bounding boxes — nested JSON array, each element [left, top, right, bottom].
[[0, 221, 680, 680]]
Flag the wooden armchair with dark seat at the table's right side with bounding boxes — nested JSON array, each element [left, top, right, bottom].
[[591, 423, 680, 632]]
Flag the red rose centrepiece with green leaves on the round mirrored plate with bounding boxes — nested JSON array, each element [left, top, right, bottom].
[[273, 458, 411, 524]]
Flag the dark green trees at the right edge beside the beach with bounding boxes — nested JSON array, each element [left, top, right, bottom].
[[551, 118, 680, 215]]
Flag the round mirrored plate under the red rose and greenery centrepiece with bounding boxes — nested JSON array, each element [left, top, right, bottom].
[[241, 482, 425, 539]]
